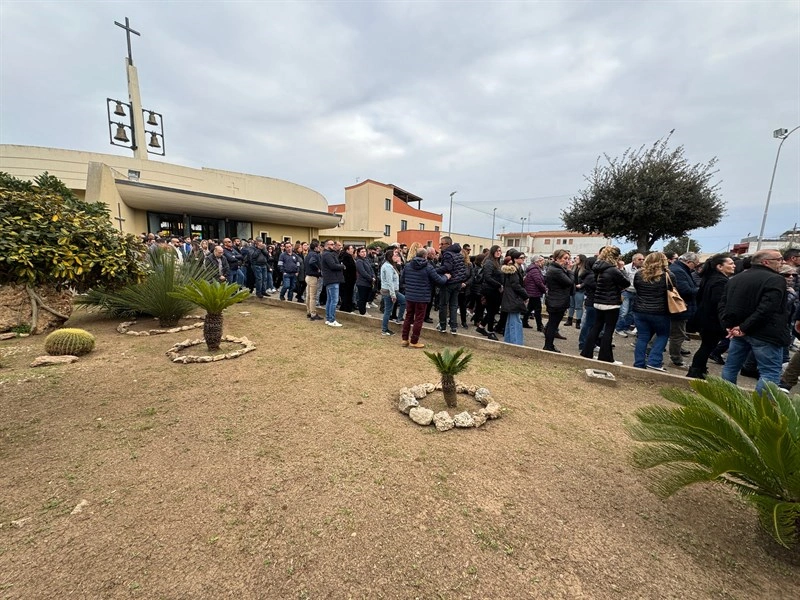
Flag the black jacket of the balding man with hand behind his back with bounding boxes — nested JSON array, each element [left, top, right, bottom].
[[719, 265, 790, 346]]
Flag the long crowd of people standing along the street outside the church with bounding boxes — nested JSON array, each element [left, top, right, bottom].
[[139, 234, 800, 390]]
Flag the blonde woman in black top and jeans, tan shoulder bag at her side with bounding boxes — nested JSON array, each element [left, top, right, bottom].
[[633, 252, 670, 372]]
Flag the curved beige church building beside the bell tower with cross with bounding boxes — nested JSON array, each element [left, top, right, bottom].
[[0, 145, 339, 241]]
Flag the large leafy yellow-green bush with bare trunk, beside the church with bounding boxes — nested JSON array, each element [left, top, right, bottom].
[[0, 172, 144, 332]]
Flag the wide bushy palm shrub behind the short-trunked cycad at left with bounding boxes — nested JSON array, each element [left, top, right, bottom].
[[75, 250, 213, 327]]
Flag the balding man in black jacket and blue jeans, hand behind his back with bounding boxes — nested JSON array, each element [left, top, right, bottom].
[[719, 250, 789, 393]]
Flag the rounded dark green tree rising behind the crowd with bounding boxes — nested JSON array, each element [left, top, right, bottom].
[[561, 132, 725, 252]]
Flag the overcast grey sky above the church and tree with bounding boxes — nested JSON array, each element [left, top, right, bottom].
[[0, 0, 800, 251]]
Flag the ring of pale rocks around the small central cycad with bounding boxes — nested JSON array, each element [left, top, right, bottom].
[[397, 383, 503, 431]]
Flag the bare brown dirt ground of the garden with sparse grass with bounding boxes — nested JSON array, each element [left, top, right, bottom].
[[0, 299, 800, 600]]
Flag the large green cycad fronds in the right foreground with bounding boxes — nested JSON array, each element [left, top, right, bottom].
[[627, 377, 800, 548]]
